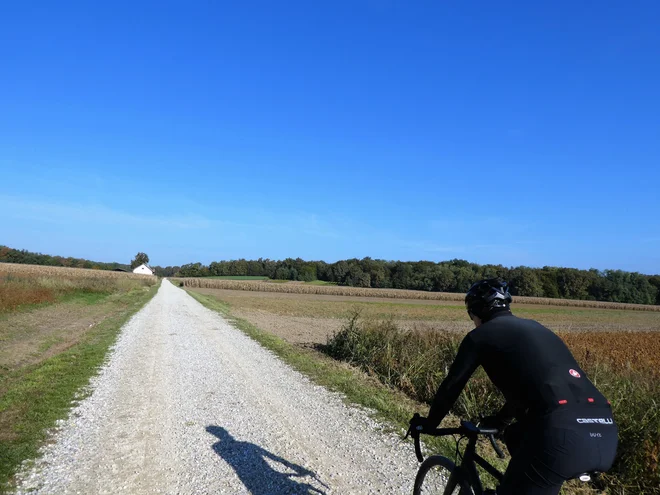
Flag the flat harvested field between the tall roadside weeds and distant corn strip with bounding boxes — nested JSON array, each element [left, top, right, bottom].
[[188, 289, 660, 344]]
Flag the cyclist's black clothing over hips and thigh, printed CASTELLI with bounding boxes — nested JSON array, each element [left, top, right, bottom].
[[497, 406, 618, 495]]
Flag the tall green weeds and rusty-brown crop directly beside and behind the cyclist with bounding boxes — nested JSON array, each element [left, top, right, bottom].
[[323, 312, 660, 493]]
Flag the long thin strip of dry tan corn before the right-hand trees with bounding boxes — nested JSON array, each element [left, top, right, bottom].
[[172, 278, 660, 312]]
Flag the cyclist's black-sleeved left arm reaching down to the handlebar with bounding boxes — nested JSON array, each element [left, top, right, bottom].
[[428, 334, 480, 428]]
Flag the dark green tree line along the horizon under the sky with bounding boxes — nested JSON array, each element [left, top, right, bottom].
[[0, 246, 660, 304]]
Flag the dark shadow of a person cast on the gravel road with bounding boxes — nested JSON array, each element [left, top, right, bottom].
[[206, 425, 327, 495]]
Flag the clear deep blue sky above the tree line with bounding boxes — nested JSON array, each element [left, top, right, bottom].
[[0, 0, 660, 273]]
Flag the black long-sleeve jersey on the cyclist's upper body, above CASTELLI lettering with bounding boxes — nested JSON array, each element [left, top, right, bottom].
[[428, 311, 608, 427]]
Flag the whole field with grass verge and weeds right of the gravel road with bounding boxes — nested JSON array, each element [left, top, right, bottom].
[[189, 288, 660, 494]]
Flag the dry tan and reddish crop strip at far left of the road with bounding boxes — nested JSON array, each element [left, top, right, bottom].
[[0, 263, 158, 312]]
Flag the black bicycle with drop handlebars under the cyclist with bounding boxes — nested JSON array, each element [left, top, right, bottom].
[[406, 415, 595, 495]]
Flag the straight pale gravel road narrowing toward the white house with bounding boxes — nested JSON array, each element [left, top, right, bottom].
[[17, 281, 417, 495]]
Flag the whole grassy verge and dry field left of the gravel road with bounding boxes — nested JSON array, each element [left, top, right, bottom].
[[0, 264, 159, 493]]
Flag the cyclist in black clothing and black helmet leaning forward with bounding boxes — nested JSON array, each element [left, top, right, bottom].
[[411, 279, 618, 495]]
